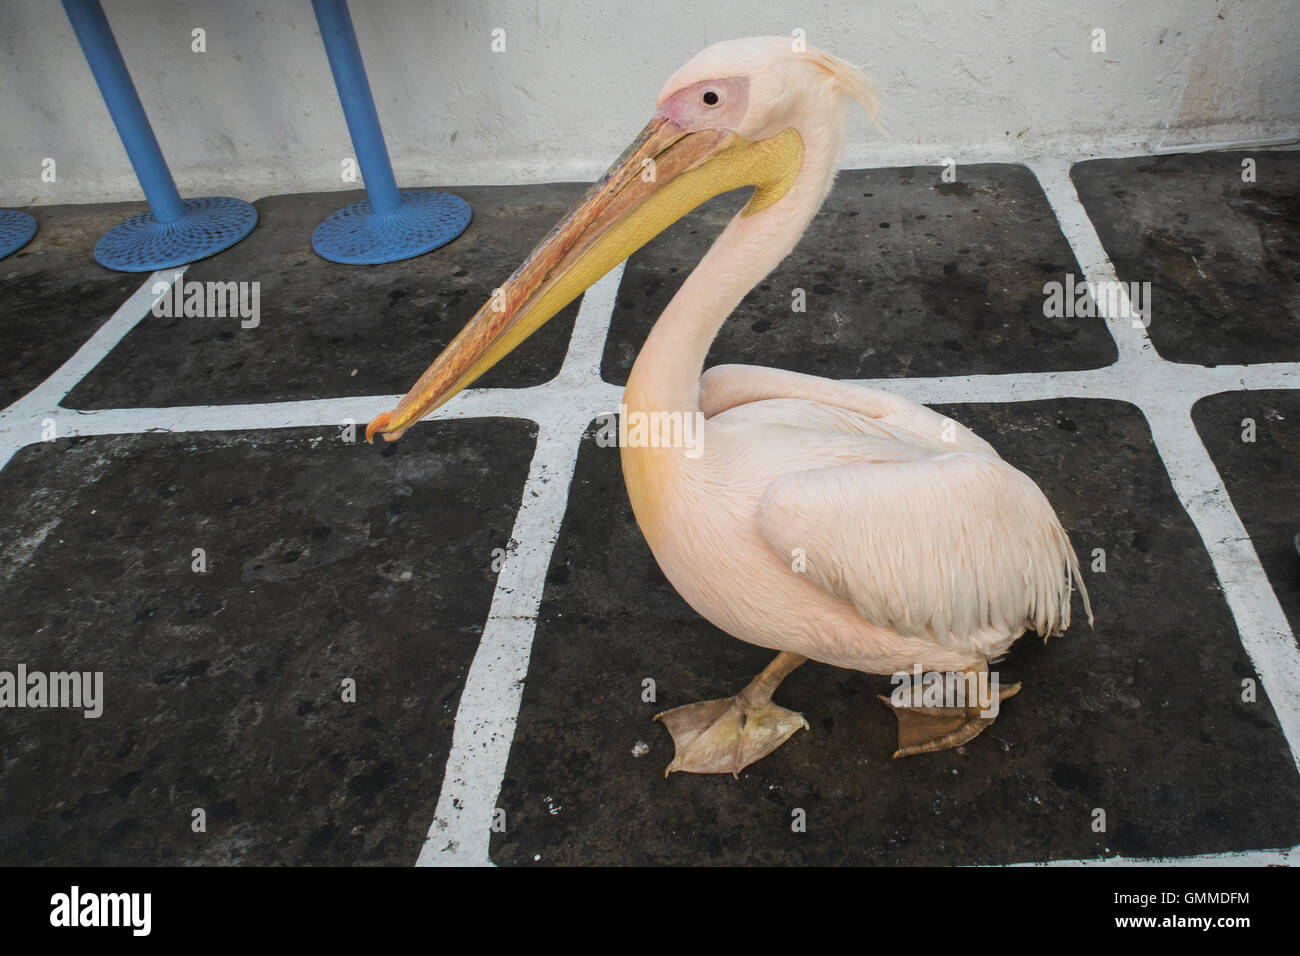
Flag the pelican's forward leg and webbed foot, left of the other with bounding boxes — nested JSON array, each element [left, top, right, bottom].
[[654, 653, 809, 777]]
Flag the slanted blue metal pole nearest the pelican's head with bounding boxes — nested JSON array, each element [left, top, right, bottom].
[[312, 0, 402, 216]]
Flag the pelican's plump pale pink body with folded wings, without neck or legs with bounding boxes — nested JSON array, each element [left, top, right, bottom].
[[623, 365, 1073, 674]]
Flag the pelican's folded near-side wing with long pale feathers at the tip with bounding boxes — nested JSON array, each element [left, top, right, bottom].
[[758, 440, 1092, 644]]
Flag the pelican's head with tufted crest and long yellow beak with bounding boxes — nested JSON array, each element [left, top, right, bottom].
[[365, 36, 875, 441]]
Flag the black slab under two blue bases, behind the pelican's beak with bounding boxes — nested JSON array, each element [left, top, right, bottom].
[[65, 183, 586, 408]]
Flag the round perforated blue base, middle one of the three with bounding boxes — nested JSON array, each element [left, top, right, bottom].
[[95, 196, 257, 272]]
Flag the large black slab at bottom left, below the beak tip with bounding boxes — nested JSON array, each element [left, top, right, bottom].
[[0, 419, 533, 865]]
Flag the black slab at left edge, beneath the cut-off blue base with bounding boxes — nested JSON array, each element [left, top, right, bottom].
[[0, 203, 148, 405]]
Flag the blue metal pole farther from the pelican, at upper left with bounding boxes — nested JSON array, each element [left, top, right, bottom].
[[64, 0, 185, 222]]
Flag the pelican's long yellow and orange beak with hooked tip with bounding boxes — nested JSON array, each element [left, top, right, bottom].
[[365, 114, 803, 441]]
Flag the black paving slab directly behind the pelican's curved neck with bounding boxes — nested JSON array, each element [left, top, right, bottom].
[[602, 164, 1115, 385]]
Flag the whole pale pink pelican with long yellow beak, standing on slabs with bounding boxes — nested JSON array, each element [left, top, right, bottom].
[[367, 36, 1092, 775]]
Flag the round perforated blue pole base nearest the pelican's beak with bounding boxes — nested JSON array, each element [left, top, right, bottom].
[[312, 189, 471, 265]]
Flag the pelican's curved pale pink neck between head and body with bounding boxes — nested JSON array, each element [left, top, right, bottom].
[[624, 125, 840, 414]]
